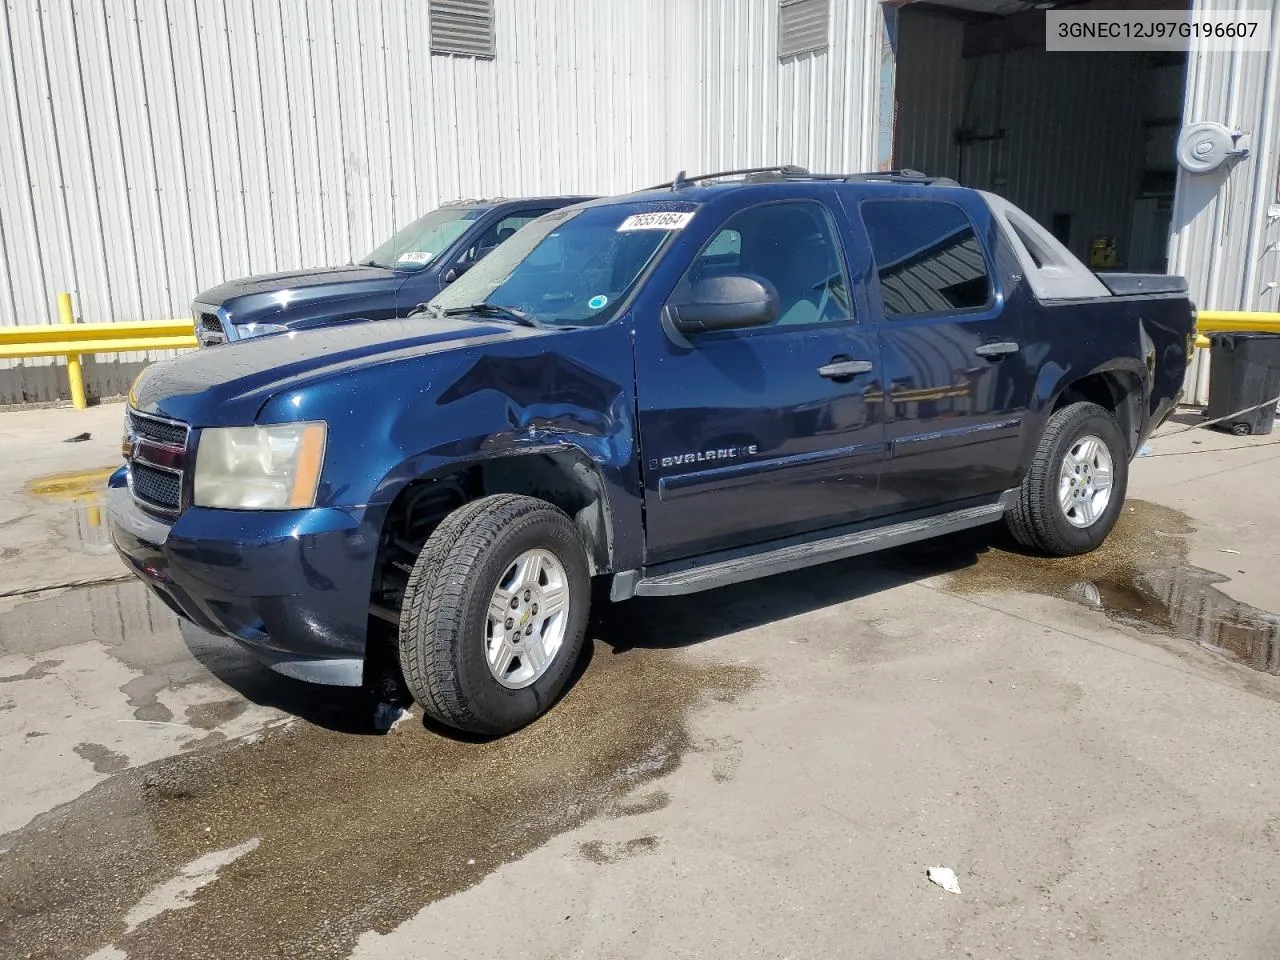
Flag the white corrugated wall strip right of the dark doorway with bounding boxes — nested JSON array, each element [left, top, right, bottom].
[[1169, 0, 1280, 402]]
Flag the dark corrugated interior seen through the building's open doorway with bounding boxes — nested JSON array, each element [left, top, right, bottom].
[[896, 8, 1148, 267]]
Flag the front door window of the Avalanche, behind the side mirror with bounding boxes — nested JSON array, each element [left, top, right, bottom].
[[675, 201, 852, 326]]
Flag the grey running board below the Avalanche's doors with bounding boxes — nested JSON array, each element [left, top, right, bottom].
[[611, 490, 1016, 600]]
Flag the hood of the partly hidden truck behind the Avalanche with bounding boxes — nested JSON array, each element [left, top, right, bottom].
[[195, 266, 408, 323]]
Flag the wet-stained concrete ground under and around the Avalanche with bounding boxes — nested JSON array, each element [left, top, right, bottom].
[[0, 407, 1280, 960]]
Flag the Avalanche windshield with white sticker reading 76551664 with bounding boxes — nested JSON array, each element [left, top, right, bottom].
[[431, 204, 691, 326]]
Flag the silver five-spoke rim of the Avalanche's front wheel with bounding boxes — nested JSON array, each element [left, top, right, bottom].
[[484, 549, 568, 690]]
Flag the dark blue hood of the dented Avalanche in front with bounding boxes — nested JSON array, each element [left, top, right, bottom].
[[129, 316, 549, 426]]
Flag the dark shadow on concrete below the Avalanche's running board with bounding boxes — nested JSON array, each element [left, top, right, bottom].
[[589, 526, 1011, 654]]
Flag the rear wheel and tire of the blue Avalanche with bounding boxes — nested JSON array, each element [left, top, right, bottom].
[[1005, 403, 1129, 557]]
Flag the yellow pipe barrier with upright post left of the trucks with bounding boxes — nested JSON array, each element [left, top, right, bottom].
[[0, 293, 200, 401]]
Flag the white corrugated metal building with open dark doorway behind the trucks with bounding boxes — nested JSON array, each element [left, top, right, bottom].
[[0, 0, 1280, 403]]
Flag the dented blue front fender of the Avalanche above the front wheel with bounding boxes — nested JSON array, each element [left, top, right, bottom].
[[259, 326, 643, 564]]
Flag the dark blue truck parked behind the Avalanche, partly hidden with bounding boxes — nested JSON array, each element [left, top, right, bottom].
[[191, 197, 591, 347]]
